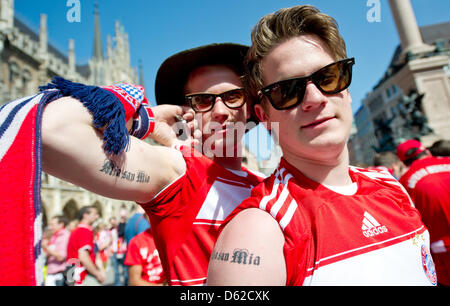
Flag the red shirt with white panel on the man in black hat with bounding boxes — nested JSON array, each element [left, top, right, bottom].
[[141, 147, 263, 286]]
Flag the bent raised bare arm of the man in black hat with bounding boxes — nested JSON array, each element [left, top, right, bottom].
[[42, 97, 193, 202]]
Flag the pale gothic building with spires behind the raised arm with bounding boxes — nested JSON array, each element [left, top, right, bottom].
[[0, 0, 142, 223]]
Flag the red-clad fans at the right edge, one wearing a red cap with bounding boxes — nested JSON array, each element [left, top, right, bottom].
[[358, 139, 450, 286]]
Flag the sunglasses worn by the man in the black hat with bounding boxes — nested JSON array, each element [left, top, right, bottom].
[[185, 88, 245, 113]]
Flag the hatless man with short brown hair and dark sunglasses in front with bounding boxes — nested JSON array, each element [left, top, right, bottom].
[[208, 6, 436, 285]]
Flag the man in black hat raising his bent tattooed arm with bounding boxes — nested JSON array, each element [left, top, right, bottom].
[[43, 43, 262, 285]]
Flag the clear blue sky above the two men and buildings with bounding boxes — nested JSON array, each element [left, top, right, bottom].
[[14, 0, 450, 157]]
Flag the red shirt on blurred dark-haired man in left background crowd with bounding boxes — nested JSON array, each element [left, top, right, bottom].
[[67, 224, 95, 285]]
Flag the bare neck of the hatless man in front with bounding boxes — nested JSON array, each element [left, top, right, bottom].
[[284, 148, 352, 186]]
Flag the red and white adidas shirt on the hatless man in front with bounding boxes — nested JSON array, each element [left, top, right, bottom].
[[221, 159, 436, 286]]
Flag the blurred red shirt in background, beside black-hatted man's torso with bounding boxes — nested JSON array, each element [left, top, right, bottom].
[[125, 229, 164, 284]]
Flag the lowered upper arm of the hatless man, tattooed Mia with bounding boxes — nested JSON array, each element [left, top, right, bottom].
[[207, 208, 286, 286]]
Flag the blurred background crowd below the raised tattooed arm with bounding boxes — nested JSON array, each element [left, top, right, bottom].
[[42, 206, 165, 286]]
